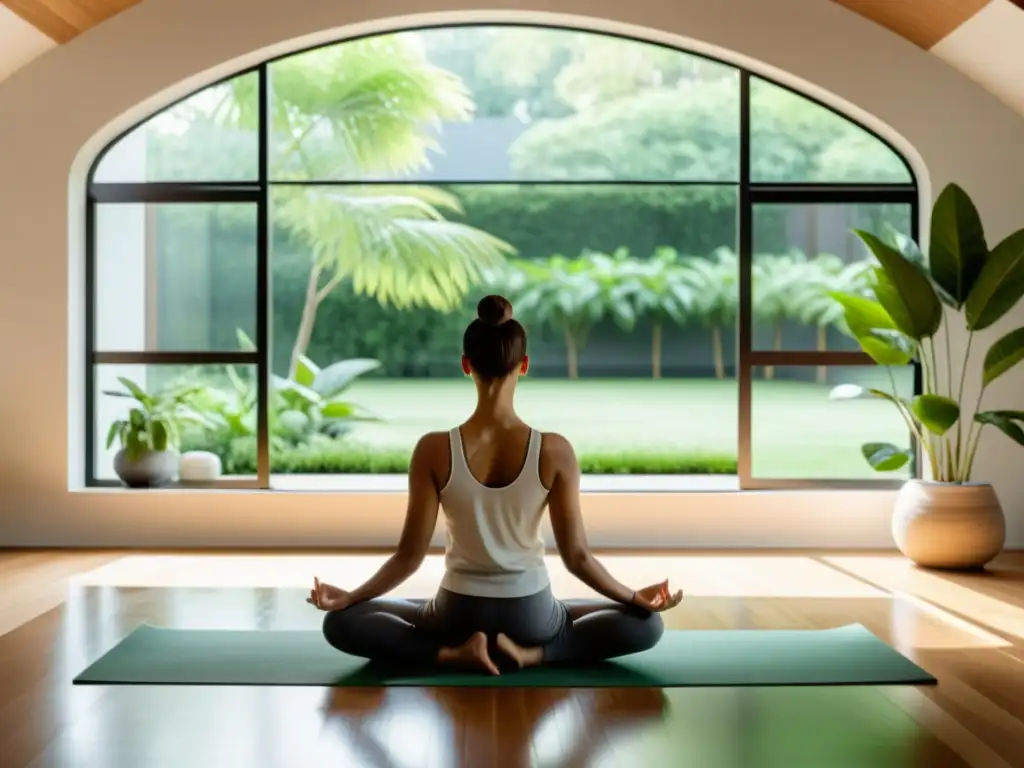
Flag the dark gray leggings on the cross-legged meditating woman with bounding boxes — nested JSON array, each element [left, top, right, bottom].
[[324, 588, 665, 665]]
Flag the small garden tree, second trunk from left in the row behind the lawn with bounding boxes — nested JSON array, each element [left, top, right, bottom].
[[624, 248, 695, 379]]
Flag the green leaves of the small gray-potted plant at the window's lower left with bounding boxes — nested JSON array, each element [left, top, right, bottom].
[[103, 376, 209, 460]]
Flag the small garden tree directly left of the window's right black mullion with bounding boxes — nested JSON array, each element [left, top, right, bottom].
[[681, 248, 739, 380]]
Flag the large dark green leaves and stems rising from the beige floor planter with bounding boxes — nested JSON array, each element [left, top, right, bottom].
[[838, 184, 1024, 482]]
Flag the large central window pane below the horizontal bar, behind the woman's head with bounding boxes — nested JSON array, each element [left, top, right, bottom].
[[271, 184, 737, 481]]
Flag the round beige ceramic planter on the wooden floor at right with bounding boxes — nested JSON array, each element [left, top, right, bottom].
[[893, 480, 1007, 568]]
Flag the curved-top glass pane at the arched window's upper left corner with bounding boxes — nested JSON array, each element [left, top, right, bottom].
[[93, 73, 259, 182]]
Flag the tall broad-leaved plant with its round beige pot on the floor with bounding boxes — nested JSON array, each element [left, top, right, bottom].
[[833, 184, 1024, 568]]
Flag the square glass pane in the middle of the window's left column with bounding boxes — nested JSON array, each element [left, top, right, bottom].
[[95, 204, 256, 351]]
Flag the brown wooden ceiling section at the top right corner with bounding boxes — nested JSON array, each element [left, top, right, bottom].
[[833, 0, 991, 50]]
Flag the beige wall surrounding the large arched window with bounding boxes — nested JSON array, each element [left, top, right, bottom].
[[0, 0, 1024, 547]]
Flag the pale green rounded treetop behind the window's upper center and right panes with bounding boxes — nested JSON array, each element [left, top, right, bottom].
[[510, 74, 910, 183]]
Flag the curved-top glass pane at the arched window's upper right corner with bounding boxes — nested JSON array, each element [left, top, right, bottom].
[[751, 78, 913, 183]]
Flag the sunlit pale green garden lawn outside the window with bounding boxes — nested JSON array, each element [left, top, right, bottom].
[[348, 378, 908, 478]]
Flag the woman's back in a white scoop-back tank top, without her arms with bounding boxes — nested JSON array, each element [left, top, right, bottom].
[[440, 420, 549, 598]]
